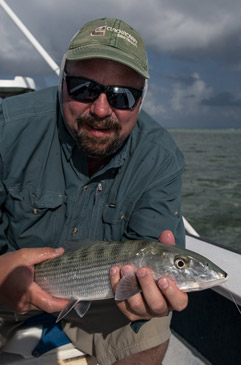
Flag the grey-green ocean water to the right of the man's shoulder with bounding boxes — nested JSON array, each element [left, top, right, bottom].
[[169, 129, 241, 253]]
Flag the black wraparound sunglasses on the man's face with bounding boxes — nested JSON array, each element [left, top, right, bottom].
[[64, 72, 143, 110]]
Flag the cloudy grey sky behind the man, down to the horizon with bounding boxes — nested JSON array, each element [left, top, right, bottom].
[[0, 0, 241, 128]]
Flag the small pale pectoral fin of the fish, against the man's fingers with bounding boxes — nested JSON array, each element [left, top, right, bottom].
[[115, 271, 141, 301]]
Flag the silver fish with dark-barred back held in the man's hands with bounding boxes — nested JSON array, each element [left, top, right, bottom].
[[35, 240, 227, 319]]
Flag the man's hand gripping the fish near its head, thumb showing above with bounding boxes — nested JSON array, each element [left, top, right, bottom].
[[111, 231, 188, 321]]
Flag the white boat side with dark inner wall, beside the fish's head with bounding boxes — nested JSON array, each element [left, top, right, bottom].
[[168, 226, 241, 365]]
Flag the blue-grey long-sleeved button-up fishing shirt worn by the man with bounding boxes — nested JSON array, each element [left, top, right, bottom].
[[0, 87, 184, 250]]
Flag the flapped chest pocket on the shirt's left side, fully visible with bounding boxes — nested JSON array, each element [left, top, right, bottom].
[[5, 187, 63, 247]]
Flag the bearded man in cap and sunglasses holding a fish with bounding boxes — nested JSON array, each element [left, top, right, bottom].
[[0, 18, 187, 365]]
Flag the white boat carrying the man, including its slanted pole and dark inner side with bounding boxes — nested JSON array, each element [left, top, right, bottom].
[[0, 0, 241, 365]]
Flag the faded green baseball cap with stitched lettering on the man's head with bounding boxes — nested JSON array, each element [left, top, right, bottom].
[[65, 18, 149, 79]]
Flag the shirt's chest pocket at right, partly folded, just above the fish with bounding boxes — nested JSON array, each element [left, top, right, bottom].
[[102, 202, 134, 241]]
